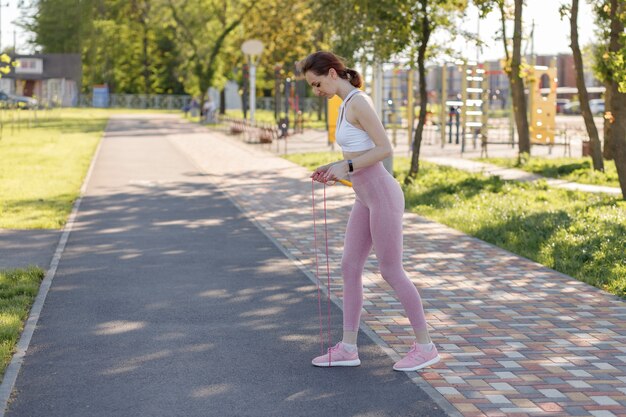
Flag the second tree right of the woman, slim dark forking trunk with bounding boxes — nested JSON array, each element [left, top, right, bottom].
[[474, 0, 530, 155]]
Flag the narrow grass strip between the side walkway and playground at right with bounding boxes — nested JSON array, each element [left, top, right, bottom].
[[477, 156, 619, 188]]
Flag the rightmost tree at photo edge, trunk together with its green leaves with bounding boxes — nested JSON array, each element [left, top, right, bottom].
[[593, 0, 626, 199]]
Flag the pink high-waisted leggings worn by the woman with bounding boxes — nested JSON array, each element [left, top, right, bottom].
[[341, 162, 426, 333]]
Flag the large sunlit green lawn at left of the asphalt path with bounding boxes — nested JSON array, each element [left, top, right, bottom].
[[0, 109, 180, 229]]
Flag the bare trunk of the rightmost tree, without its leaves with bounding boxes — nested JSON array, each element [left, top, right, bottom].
[[609, 0, 626, 200]]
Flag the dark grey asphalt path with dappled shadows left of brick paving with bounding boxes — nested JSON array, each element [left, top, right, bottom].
[[5, 117, 445, 417]]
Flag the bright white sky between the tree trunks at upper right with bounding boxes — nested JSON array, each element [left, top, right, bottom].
[[456, 0, 595, 61]]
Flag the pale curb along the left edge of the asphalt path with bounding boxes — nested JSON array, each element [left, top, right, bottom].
[[0, 122, 109, 417]]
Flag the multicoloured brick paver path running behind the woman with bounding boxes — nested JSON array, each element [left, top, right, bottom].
[[171, 118, 626, 417]]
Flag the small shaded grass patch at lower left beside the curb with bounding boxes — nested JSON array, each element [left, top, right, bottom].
[[0, 267, 44, 375]]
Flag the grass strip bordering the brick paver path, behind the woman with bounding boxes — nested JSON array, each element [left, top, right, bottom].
[[287, 152, 626, 297]]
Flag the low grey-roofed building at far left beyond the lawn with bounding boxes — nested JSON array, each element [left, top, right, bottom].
[[0, 54, 82, 106]]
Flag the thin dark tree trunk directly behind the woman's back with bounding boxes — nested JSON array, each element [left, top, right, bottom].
[[404, 0, 432, 185]]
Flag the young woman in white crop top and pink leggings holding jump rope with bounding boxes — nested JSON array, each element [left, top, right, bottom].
[[302, 52, 440, 371]]
